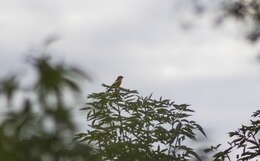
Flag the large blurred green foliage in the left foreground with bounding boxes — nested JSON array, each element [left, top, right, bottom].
[[0, 56, 97, 161]]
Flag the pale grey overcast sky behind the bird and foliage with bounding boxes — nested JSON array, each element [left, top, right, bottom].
[[0, 0, 260, 150]]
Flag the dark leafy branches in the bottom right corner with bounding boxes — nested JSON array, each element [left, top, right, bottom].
[[214, 110, 260, 161]]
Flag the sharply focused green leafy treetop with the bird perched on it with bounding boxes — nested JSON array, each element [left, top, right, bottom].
[[77, 85, 206, 161]]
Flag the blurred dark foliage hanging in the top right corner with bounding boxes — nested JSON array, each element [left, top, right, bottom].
[[183, 0, 260, 43]]
